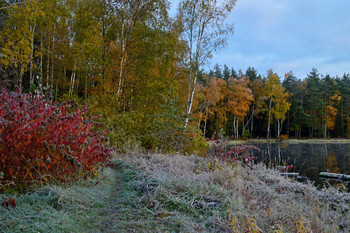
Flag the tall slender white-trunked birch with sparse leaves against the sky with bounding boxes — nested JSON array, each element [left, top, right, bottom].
[[178, 0, 236, 129]]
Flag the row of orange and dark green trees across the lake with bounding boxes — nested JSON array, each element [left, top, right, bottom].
[[197, 64, 350, 138]]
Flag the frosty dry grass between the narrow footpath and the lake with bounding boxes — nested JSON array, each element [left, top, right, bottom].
[[118, 153, 350, 232]]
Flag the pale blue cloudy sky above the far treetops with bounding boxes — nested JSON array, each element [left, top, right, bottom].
[[171, 0, 350, 79]]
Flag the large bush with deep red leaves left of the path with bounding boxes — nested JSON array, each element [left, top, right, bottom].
[[0, 89, 111, 188]]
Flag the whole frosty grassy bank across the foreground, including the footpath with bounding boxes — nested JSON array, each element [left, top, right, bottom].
[[0, 153, 350, 232]]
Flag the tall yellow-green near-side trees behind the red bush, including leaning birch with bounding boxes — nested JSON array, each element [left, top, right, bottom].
[[0, 0, 235, 149]]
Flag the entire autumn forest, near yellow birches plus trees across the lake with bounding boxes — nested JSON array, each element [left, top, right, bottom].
[[0, 0, 350, 147]]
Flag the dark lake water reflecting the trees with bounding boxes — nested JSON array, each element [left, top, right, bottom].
[[247, 143, 350, 188]]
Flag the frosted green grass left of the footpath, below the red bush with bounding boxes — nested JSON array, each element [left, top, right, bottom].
[[0, 169, 115, 232]]
